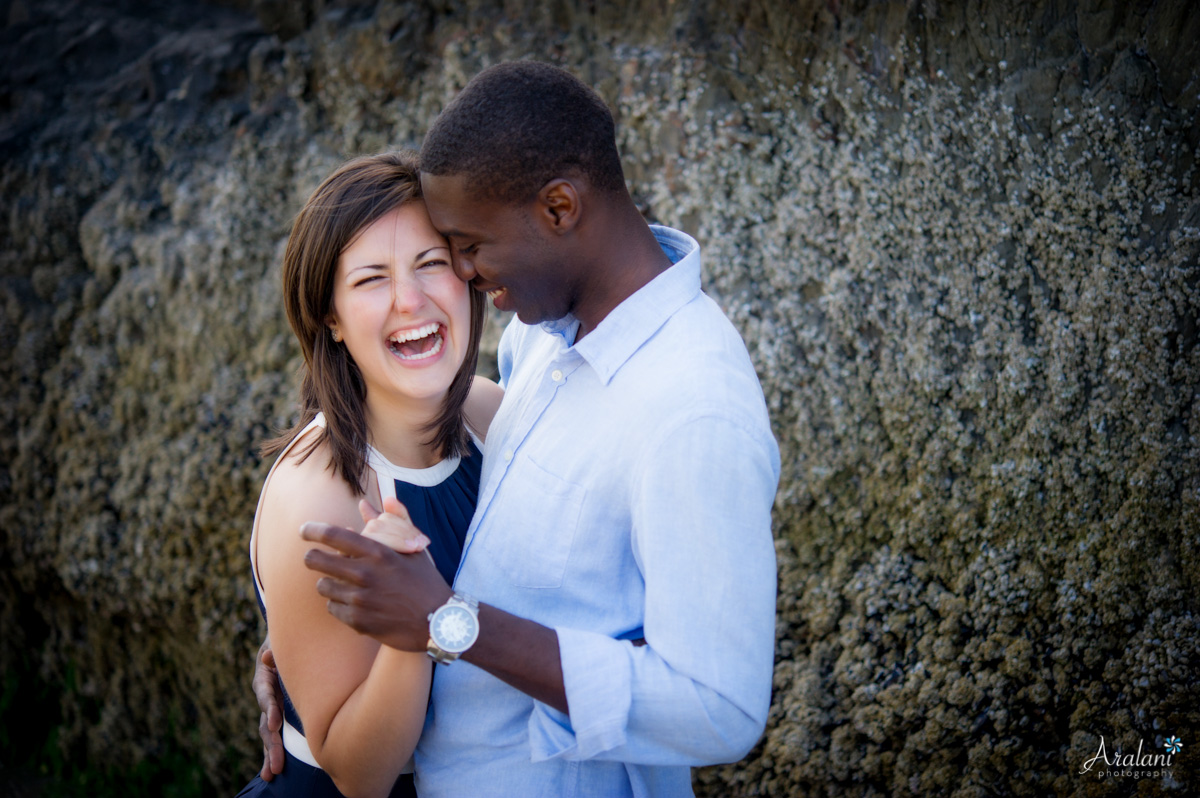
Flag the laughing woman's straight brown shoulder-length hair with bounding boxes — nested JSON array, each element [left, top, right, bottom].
[[263, 151, 485, 494]]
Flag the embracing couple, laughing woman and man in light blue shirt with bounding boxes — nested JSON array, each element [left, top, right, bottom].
[[241, 61, 779, 798]]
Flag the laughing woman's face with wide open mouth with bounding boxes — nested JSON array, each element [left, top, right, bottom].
[[329, 202, 470, 412]]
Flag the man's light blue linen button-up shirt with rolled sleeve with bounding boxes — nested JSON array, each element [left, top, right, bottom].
[[416, 227, 779, 798]]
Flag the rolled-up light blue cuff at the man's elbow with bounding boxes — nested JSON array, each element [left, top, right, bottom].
[[529, 629, 632, 762]]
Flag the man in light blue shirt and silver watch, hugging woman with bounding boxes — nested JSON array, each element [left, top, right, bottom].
[[260, 62, 779, 798]]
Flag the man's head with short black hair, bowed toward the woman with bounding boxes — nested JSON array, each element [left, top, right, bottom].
[[421, 61, 632, 324]]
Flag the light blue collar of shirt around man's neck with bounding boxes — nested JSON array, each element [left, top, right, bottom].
[[541, 224, 700, 385]]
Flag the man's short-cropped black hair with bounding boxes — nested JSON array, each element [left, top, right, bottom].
[[421, 61, 625, 203]]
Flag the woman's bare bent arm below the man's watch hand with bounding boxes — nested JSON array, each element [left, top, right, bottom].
[[257, 441, 432, 797]]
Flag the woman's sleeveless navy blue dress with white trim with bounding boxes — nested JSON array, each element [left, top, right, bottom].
[[238, 436, 484, 798]]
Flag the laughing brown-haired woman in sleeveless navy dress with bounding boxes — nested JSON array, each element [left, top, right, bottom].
[[241, 154, 500, 796]]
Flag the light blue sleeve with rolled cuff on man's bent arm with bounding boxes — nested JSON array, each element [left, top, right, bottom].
[[529, 407, 779, 766]]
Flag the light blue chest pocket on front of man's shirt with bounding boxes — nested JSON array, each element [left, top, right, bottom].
[[487, 457, 587, 588]]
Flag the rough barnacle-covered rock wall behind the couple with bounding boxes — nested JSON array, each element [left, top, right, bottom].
[[0, 0, 1200, 797]]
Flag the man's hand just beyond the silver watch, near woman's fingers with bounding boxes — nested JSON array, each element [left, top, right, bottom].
[[300, 522, 452, 652]]
